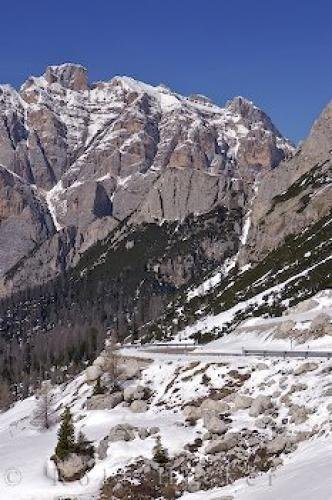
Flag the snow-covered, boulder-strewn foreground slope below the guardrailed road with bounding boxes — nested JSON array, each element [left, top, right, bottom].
[[0, 318, 332, 500]]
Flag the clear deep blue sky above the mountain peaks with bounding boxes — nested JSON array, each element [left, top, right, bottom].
[[0, 0, 332, 142]]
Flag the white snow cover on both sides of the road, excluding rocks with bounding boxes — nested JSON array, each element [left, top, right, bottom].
[[0, 292, 332, 500]]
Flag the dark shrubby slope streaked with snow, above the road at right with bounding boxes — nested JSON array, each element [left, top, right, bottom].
[[143, 211, 332, 342]]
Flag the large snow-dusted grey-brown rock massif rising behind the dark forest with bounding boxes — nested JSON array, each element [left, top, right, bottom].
[[0, 64, 292, 290]]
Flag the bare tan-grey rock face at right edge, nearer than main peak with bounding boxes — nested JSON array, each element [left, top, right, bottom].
[[241, 103, 332, 263]]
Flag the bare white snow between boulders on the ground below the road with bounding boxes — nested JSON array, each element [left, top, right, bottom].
[[0, 354, 332, 500]]
